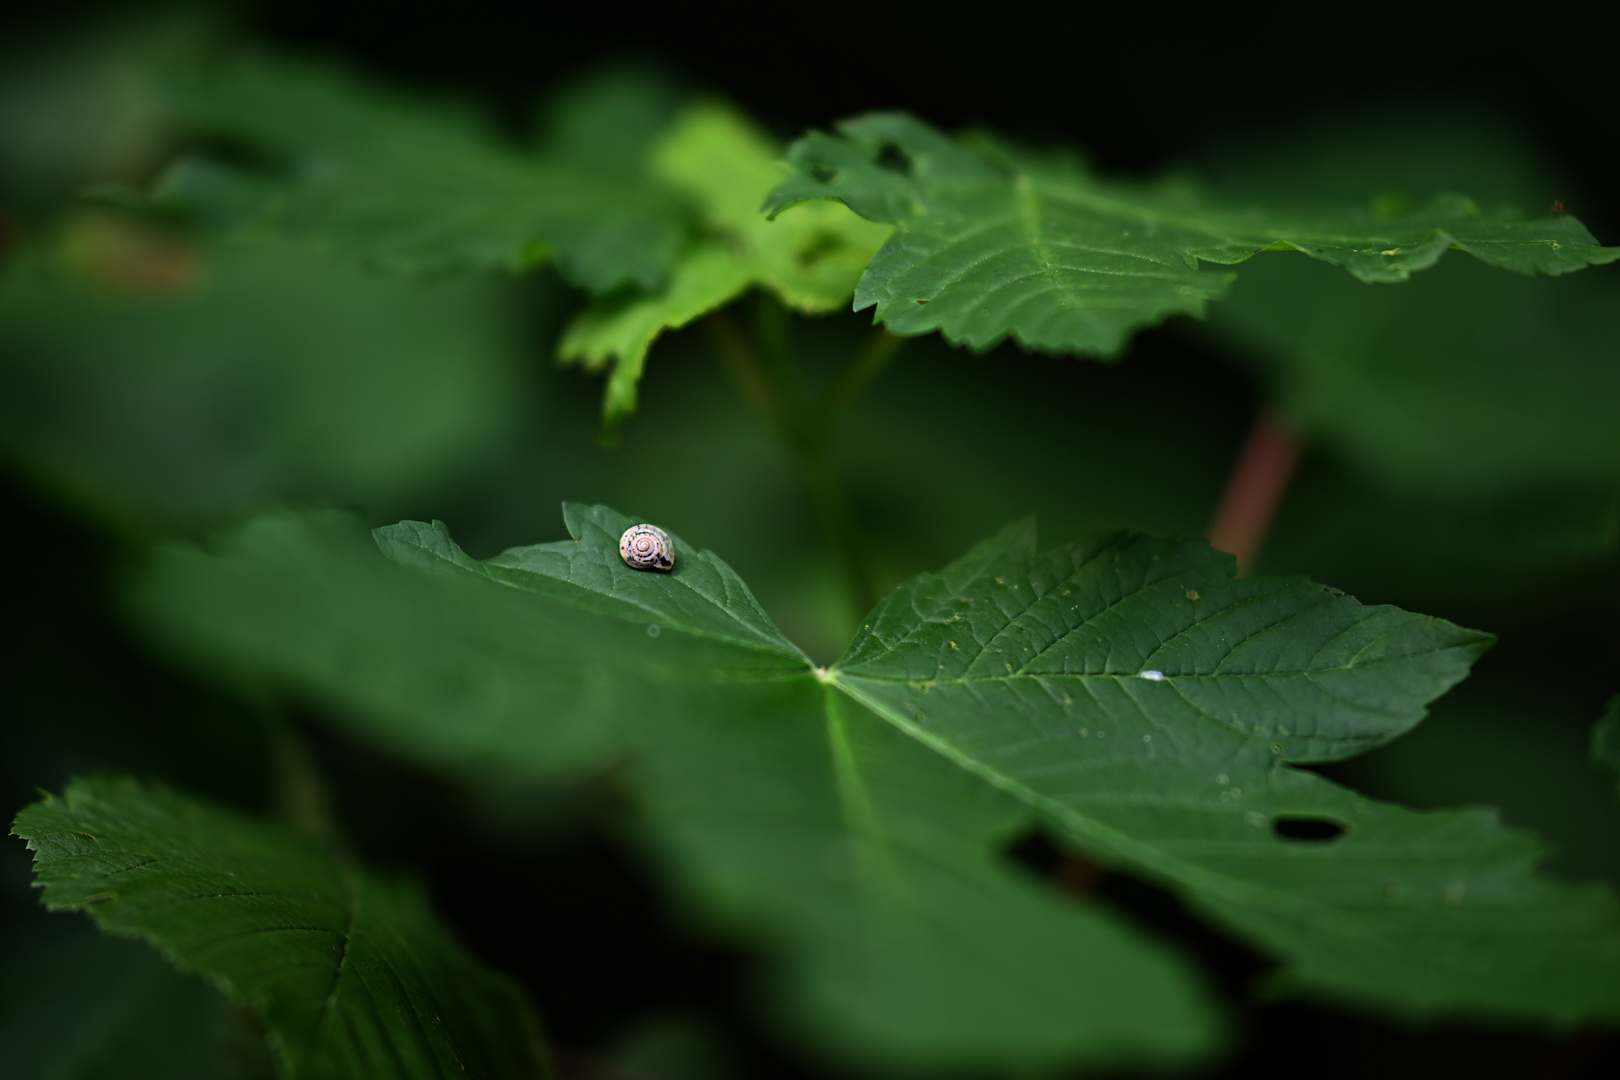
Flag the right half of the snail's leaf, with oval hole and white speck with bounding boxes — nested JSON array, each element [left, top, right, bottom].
[[834, 528, 1620, 1023]]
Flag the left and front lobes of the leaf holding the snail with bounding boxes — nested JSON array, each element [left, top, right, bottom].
[[136, 507, 1217, 1069]]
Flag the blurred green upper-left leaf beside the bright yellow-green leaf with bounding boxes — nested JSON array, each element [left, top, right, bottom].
[[144, 55, 687, 291]]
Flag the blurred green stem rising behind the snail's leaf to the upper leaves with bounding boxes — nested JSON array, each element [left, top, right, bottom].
[[703, 300, 893, 614]]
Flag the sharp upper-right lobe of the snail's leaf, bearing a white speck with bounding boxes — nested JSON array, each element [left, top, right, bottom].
[[834, 521, 1492, 761]]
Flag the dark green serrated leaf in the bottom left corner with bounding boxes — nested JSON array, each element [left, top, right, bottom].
[[13, 779, 548, 1077]]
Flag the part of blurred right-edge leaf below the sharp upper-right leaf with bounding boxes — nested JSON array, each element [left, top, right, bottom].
[[1212, 236, 1620, 498]]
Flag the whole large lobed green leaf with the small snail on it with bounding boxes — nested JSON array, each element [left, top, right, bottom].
[[139, 507, 1620, 1064]]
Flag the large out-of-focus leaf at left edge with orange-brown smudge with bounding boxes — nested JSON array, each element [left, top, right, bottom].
[[0, 215, 520, 521]]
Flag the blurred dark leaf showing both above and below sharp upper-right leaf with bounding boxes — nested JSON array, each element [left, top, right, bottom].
[[1210, 108, 1620, 498]]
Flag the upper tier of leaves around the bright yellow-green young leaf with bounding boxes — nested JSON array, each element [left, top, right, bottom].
[[107, 46, 1620, 439]]
